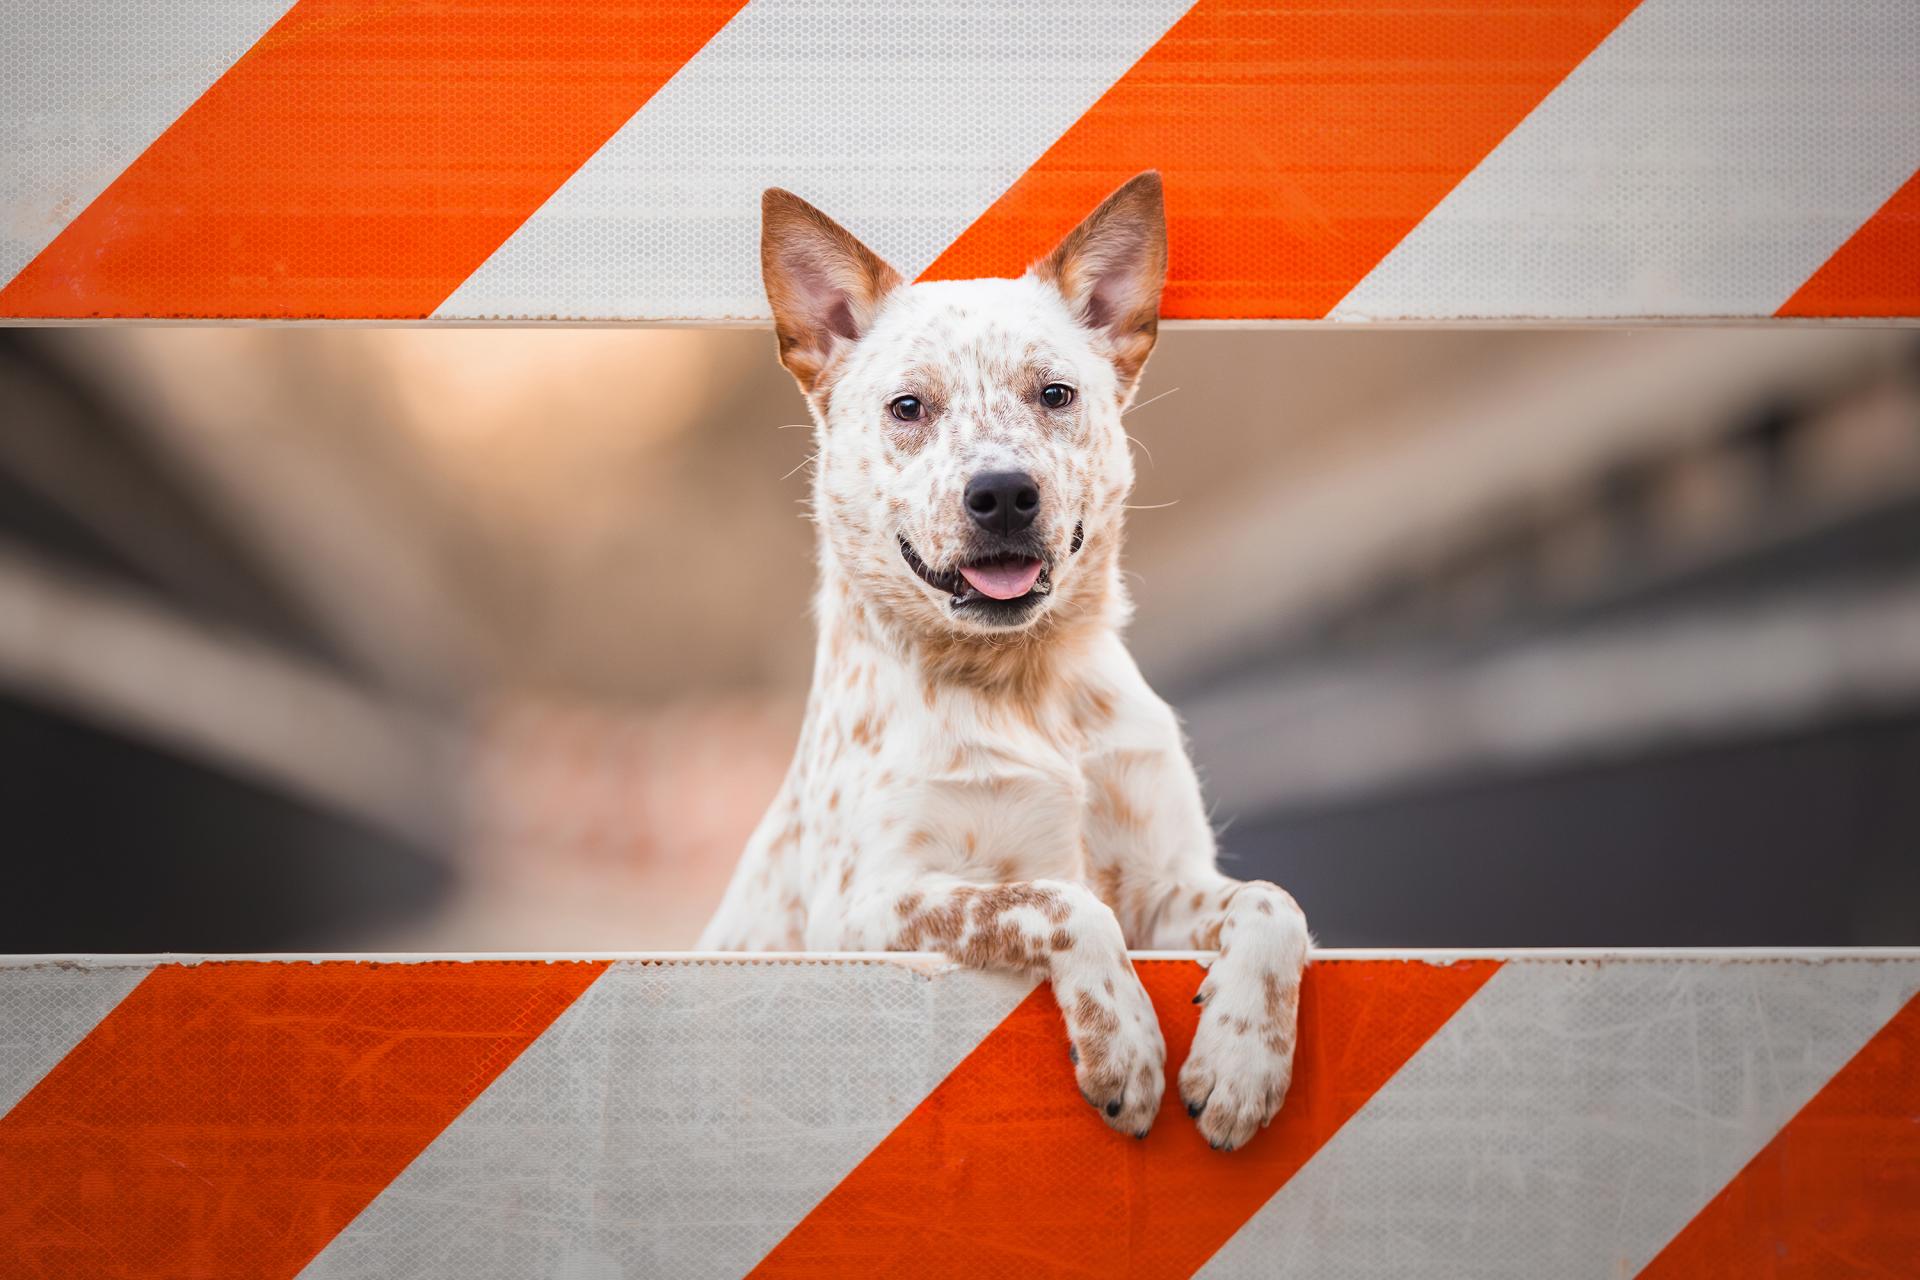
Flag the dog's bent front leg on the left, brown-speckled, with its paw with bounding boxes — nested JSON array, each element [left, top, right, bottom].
[[847, 875, 1167, 1138]]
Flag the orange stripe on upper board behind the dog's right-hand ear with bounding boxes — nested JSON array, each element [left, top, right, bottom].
[[924, 0, 1638, 319]]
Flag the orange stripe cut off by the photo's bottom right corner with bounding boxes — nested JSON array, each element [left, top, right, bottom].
[[1640, 998, 1920, 1280]]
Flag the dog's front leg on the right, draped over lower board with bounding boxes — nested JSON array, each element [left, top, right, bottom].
[[1148, 873, 1309, 1151]]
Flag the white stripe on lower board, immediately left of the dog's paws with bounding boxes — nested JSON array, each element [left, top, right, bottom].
[[301, 961, 1033, 1280]]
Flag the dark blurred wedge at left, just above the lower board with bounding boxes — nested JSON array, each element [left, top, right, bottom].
[[0, 700, 453, 952]]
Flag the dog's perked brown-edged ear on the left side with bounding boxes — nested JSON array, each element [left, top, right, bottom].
[[760, 186, 900, 393]]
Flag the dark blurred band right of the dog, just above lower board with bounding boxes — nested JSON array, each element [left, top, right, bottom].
[[1223, 716, 1920, 946]]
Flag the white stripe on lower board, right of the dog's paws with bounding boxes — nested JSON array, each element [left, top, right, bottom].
[[1202, 960, 1920, 1280]]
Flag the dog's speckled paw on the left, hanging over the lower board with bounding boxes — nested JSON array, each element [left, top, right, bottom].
[[1054, 958, 1167, 1138]]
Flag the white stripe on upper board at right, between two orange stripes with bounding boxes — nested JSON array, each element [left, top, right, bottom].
[[1332, 0, 1920, 320]]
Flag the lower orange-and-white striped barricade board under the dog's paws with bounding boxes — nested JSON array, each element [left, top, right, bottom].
[[0, 952, 1920, 1280]]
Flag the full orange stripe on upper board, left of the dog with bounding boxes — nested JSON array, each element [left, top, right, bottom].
[[0, 0, 745, 319]]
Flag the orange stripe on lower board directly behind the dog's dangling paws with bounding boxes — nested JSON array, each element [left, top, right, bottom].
[[753, 960, 1500, 1278]]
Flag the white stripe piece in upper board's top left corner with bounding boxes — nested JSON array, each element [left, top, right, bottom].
[[0, 0, 292, 284]]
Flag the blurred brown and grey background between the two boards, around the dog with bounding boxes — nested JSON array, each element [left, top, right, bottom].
[[0, 326, 1920, 952]]
